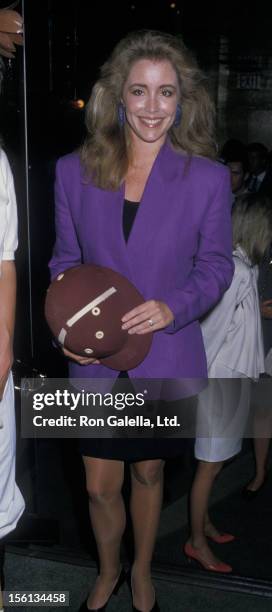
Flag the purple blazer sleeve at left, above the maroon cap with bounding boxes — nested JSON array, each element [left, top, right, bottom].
[[49, 159, 82, 279]]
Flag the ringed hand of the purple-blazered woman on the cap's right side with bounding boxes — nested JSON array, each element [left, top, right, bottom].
[[122, 300, 174, 335]]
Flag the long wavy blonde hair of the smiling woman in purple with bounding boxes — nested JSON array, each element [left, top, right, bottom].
[[80, 30, 216, 190]]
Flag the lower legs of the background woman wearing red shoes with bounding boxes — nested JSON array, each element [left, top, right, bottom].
[[189, 461, 223, 564]]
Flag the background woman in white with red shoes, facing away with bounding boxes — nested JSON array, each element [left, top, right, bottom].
[[184, 194, 272, 572]]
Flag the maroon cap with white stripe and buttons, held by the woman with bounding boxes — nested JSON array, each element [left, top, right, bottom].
[[45, 264, 152, 370]]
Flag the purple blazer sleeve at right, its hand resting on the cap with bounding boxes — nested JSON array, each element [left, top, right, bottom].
[[164, 172, 234, 333]]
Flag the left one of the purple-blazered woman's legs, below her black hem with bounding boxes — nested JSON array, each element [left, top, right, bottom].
[[83, 457, 125, 608]]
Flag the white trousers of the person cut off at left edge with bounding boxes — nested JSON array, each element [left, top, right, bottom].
[[0, 373, 25, 538]]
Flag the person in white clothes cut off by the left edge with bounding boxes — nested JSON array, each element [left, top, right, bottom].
[[0, 149, 25, 607]]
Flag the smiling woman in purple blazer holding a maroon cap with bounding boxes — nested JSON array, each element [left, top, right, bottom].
[[50, 31, 233, 612]]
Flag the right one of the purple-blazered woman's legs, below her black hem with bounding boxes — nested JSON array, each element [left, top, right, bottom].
[[131, 459, 164, 612]]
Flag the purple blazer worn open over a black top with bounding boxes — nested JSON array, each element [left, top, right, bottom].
[[50, 142, 233, 378]]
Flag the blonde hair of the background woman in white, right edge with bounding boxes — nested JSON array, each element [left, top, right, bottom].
[[232, 193, 272, 265]]
